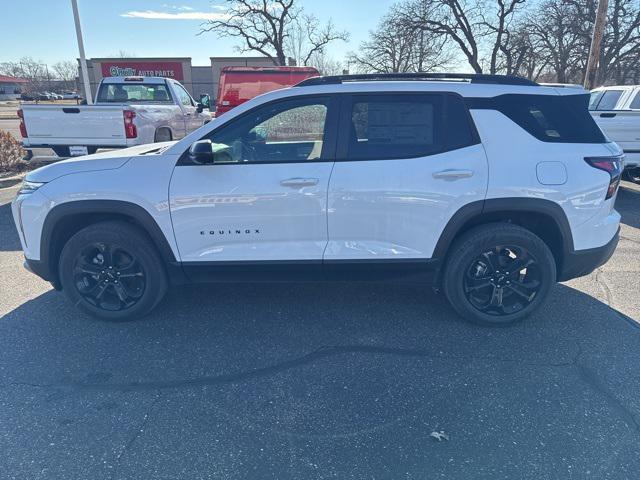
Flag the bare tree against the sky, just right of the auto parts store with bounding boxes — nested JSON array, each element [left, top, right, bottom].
[[199, 0, 349, 65]]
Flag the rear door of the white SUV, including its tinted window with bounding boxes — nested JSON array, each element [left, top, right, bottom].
[[324, 93, 487, 265]]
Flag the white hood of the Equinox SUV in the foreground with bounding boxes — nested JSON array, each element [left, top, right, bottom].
[[26, 142, 175, 182]]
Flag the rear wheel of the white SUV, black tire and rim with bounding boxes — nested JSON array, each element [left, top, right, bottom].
[[442, 223, 556, 326]]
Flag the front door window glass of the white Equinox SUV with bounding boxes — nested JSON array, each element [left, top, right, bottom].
[[205, 97, 328, 163]]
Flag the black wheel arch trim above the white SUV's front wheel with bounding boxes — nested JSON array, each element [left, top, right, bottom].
[[36, 200, 181, 286]]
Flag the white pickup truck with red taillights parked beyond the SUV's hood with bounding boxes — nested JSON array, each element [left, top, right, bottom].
[[18, 77, 211, 157]]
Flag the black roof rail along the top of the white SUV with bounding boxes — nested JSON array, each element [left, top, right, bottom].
[[296, 72, 539, 87]]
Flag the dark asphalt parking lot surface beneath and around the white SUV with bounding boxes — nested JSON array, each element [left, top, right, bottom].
[[0, 180, 640, 480]]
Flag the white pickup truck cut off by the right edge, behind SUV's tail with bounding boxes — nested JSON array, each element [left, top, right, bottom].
[[589, 85, 640, 170]]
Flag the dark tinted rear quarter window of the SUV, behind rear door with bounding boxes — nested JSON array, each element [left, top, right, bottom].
[[482, 94, 607, 143]]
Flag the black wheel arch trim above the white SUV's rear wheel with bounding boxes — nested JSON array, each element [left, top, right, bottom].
[[432, 197, 574, 266]]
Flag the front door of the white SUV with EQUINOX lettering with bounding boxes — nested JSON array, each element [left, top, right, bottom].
[[169, 96, 337, 266]]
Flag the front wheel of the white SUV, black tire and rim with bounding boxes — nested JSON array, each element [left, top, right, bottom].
[[58, 221, 167, 321]]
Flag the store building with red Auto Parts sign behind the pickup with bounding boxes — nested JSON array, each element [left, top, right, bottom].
[[78, 57, 273, 100]]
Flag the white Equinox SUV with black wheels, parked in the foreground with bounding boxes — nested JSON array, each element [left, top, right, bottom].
[[8, 74, 623, 324]]
